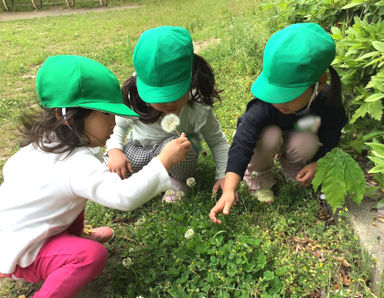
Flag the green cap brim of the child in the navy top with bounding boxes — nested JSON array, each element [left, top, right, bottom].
[[251, 73, 309, 103]]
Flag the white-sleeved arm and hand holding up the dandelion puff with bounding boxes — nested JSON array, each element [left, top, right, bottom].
[[67, 134, 191, 211]]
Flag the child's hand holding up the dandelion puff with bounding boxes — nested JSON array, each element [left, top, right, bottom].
[[157, 133, 191, 171]]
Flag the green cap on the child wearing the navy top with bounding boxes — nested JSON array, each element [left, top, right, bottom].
[[251, 23, 336, 103]]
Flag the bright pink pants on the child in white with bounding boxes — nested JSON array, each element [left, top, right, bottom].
[[6, 211, 108, 298]]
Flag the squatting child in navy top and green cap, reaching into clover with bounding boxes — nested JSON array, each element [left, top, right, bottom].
[[209, 23, 347, 223]]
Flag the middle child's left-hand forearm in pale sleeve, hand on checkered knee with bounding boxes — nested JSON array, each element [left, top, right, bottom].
[[106, 116, 133, 179]]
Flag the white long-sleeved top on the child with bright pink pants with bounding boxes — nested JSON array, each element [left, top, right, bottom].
[[0, 145, 171, 273]]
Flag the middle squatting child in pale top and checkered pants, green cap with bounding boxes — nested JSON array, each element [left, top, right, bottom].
[[107, 26, 229, 202]]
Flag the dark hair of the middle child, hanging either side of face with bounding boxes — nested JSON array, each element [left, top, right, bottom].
[[122, 54, 221, 123]]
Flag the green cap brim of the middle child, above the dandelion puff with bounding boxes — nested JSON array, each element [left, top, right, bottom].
[[136, 74, 192, 103]]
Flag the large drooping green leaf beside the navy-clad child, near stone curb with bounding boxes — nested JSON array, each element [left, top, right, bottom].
[[312, 149, 365, 212]]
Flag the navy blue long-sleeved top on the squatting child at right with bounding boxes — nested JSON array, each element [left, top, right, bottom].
[[226, 86, 347, 177]]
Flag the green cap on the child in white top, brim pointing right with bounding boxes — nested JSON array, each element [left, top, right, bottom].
[[36, 55, 138, 116]]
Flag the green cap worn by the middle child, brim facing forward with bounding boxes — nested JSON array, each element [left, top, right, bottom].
[[133, 26, 194, 103]]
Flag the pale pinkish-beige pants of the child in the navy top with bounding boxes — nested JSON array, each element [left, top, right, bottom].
[[244, 125, 321, 190]]
